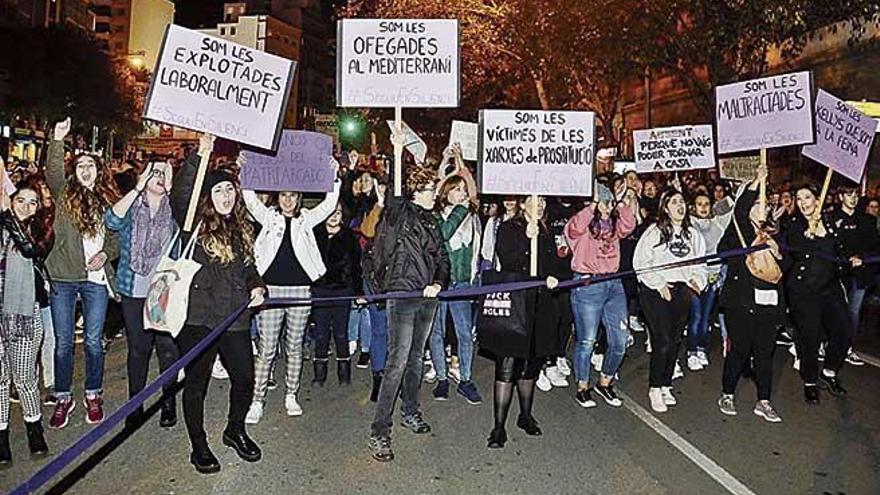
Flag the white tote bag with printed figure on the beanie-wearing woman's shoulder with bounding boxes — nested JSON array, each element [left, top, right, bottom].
[[144, 223, 202, 337]]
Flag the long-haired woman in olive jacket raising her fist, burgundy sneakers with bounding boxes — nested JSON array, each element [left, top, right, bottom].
[[46, 118, 119, 428]]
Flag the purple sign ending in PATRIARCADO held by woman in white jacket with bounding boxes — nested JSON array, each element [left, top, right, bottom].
[[240, 130, 336, 192]]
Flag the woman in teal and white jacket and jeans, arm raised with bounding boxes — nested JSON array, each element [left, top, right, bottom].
[[429, 175, 483, 404]]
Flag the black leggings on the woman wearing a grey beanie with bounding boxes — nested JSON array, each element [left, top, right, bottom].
[[177, 325, 254, 448]]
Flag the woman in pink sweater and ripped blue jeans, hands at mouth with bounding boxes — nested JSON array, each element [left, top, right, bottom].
[[565, 184, 636, 408]]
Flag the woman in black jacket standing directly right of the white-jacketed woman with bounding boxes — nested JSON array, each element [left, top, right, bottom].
[[312, 202, 363, 387]]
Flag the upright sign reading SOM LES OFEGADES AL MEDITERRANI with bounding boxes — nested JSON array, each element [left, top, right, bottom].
[[336, 19, 461, 108]]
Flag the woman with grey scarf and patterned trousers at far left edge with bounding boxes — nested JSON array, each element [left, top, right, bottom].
[[0, 179, 53, 464]]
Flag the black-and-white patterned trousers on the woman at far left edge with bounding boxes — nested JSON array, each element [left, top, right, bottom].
[[0, 308, 43, 430]]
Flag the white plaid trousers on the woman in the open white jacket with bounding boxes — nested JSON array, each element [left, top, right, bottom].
[[254, 285, 311, 401]]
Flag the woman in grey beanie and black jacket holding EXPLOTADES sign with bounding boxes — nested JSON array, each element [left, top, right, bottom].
[[171, 136, 266, 473]]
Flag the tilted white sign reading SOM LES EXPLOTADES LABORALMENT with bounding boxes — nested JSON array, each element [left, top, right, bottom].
[[144, 25, 296, 149]]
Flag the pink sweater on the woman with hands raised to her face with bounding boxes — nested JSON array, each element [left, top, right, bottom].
[[565, 205, 636, 275]]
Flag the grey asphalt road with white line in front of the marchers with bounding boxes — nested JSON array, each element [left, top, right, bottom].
[[0, 310, 880, 495]]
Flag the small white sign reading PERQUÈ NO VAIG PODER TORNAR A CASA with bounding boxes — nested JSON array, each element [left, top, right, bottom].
[[633, 125, 715, 173]]
